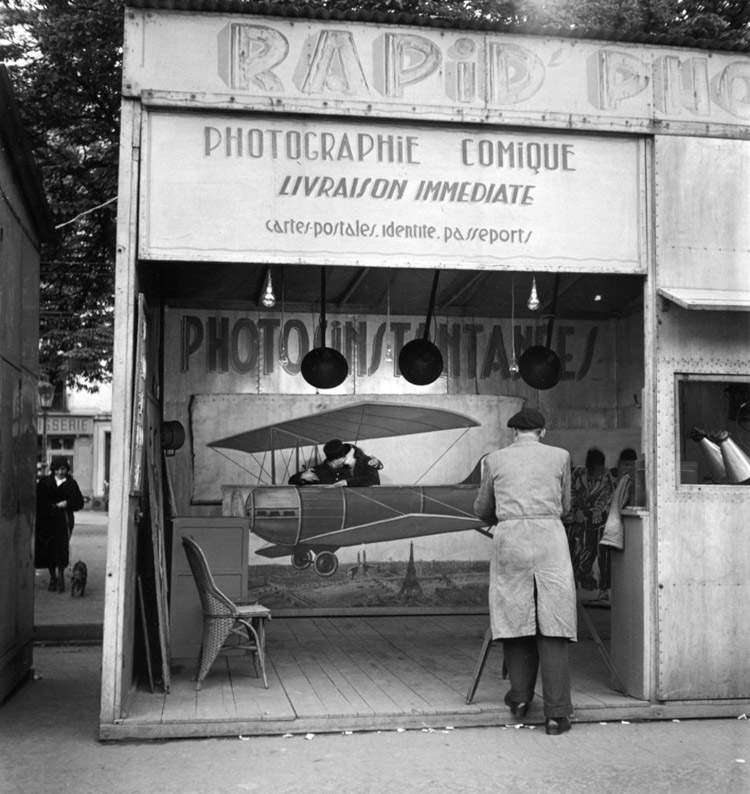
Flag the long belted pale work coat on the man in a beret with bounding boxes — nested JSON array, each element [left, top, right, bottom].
[[474, 433, 577, 640]]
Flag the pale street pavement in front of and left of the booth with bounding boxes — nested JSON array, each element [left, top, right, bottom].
[[0, 514, 750, 794]]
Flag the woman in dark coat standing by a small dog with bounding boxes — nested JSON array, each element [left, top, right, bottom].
[[34, 458, 83, 593]]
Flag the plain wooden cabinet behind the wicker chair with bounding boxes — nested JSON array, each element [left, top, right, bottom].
[[169, 517, 250, 662]]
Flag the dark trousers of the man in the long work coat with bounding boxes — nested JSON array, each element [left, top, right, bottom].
[[503, 634, 573, 719]]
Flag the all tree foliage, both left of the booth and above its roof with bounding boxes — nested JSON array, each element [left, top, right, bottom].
[[0, 0, 750, 385]]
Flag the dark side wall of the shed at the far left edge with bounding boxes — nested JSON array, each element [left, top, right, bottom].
[[0, 65, 53, 702]]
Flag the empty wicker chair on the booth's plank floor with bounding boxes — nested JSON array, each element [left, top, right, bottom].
[[182, 536, 271, 689]]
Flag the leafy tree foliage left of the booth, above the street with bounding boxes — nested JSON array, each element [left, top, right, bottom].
[[0, 0, 123, 387]]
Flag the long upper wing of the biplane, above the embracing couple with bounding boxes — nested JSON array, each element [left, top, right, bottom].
[[208, 402, 479, 453]]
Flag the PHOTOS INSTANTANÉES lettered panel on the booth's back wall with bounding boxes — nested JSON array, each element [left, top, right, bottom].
[[164, 308, 614, 398]]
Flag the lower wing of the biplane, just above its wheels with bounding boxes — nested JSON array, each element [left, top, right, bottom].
[[296, 513, 487, 556]]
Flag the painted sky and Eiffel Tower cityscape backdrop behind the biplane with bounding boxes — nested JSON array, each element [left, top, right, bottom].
[[190, 394, 522, 608]]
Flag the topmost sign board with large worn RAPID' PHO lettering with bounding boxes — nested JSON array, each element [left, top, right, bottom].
[[123, 9, 750, 137]]
